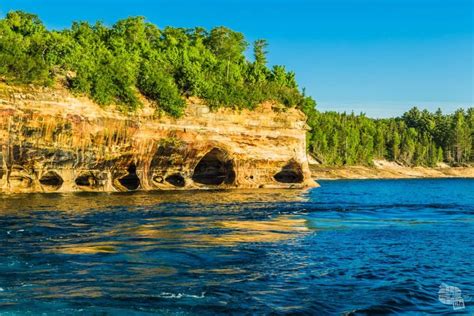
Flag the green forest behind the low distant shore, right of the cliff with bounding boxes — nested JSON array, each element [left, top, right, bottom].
[[308, 107, 474, 167]]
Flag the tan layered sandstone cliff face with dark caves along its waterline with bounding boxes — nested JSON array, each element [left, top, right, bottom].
[[0, 83, 316, 193]]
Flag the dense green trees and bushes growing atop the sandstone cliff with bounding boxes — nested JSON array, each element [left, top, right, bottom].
[[0, 11, 315, 116]]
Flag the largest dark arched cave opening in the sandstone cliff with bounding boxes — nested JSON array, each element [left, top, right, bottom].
[[192, 148, 235, 185]]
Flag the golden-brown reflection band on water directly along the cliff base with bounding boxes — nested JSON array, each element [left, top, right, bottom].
[[0, 189, 306, 215]]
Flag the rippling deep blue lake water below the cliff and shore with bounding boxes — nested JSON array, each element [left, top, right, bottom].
[[0, 179, 474, 315]]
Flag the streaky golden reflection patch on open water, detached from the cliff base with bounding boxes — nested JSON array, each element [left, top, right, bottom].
[[47, 215, 309, 255]]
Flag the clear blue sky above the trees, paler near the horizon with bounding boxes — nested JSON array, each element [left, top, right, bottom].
[[0, 0, 474, 117]]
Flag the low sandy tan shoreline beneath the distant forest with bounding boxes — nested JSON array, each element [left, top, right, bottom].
[[310, 162, 474, 180]]
